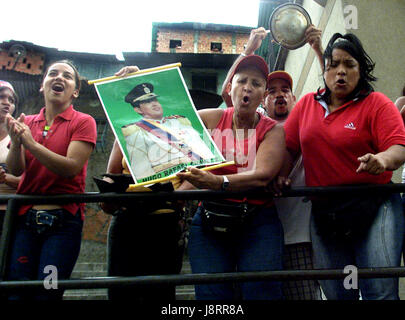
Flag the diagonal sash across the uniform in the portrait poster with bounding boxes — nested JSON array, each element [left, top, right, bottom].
[[135, 119, 202, 161]]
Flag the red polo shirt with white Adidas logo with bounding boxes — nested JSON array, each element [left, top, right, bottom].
[[284, 92, 405, 186]]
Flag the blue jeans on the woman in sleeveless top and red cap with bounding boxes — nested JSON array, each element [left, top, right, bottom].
[[188, 207, 283, 300]]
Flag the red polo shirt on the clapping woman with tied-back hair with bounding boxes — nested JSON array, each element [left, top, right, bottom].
[[17, 106, 97, 217]]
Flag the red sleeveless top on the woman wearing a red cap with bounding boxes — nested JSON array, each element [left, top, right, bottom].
[[211, 107, 277, 204]]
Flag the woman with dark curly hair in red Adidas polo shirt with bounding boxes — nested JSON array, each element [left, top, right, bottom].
[[283, 33, 405, 300]]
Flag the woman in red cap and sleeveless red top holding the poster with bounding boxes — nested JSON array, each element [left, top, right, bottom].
[[177, 55, 285, 300]]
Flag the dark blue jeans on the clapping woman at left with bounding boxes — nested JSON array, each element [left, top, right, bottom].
[[6, 211, 83, 300]]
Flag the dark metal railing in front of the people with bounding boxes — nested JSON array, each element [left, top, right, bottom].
[[0, 183, 405, 290]]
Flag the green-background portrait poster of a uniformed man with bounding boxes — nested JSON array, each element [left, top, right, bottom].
[[94, 66, 225, 183]]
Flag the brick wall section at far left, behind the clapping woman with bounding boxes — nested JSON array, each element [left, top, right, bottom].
[[0, 51, 44, 75]]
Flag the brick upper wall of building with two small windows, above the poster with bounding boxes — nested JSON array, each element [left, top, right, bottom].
[[156, 28, 249, 54]]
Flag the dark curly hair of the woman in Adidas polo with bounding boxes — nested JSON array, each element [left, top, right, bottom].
[[316, 33, 377, 103]]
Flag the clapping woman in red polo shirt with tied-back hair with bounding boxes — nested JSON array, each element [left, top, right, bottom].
[[6, 60, 97, 299]]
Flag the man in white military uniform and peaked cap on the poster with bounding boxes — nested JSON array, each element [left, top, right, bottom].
[[122, 83, 214, 179]]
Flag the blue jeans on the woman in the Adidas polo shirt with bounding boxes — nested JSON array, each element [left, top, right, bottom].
[[311, 194, 404, 300]]
